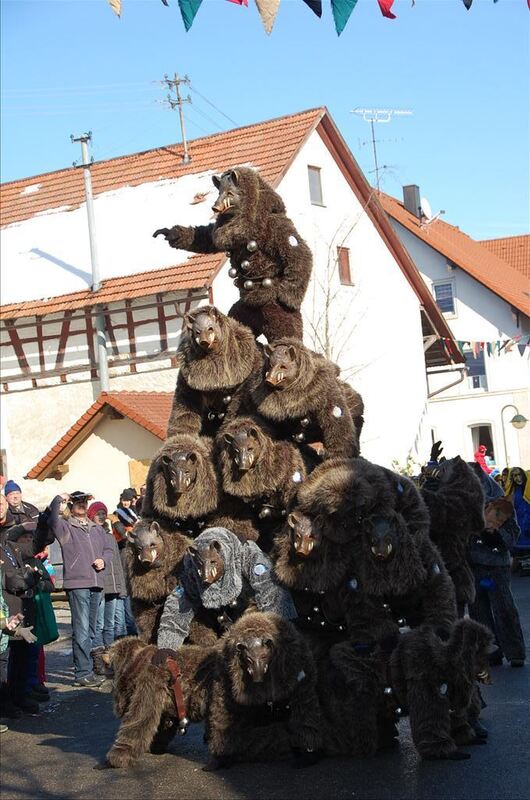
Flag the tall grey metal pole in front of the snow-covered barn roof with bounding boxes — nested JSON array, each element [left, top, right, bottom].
[[70, 131, 110, 392]]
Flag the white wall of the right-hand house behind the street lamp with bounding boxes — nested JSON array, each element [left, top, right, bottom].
[[392, 220, 530, 468]]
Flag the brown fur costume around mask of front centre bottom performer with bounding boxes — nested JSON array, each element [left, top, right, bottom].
[[206, 612, 322, 768]]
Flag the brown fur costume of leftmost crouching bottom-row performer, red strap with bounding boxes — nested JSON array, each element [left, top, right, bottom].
[[106, 636, 215, 768]]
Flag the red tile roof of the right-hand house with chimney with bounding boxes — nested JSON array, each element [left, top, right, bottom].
[[379, 193, 530, 315]]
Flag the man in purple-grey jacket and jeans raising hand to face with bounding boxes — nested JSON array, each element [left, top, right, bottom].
[[48, 492, 113, 686]]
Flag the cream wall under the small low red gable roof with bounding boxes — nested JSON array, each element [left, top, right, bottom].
[[35, 418, 162, 512]]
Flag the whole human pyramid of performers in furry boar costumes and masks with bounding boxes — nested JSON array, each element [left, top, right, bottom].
[[102, 168, 491, 769]]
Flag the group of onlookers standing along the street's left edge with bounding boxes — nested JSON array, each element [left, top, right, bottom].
[[0, 480, 142, 732]]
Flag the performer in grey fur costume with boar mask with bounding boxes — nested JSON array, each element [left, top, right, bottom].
[[158, 528, 296, 651]]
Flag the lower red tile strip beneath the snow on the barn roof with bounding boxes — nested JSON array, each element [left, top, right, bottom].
[[0, 255, 214, 320]]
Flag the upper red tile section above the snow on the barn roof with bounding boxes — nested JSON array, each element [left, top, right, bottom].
[[0, 108, 326, 226]]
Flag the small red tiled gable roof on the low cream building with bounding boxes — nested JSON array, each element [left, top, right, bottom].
[[26, 392, 173, 481]]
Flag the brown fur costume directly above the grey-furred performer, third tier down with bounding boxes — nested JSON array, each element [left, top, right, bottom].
[[217, 417, 306, 552]]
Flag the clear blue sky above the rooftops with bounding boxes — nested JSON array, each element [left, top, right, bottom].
[[1, 0, 530, 238]]
